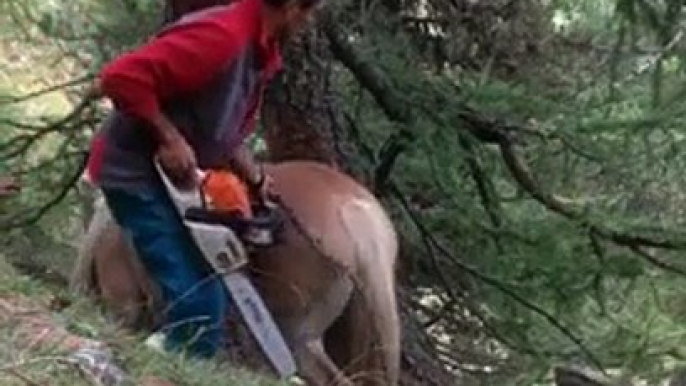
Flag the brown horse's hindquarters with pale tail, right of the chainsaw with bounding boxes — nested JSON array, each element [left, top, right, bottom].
[[262, 161, 400, 386]]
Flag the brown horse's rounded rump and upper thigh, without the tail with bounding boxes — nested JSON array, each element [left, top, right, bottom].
[[253, 161, 395, 315]]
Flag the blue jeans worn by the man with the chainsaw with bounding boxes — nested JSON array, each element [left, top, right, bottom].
[[102, 185, 229, 357]]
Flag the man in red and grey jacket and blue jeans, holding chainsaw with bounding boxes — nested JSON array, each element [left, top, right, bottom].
[[87, 0, 321, 357]]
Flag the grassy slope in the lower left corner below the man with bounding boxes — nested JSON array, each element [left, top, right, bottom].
[[0, 256, 280, 386]]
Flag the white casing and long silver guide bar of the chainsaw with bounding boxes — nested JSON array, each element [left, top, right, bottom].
[[155, 162, 296, 378]]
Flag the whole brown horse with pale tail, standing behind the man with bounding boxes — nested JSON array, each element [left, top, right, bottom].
[[68, 161, 400, 386]]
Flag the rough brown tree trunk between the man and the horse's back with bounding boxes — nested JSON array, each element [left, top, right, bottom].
[[262, 28, 348, 170]]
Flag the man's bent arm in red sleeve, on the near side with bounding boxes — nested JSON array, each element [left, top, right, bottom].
[[97, 10, 254, 141]]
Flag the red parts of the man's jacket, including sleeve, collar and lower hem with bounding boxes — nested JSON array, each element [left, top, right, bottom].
[[89, 0, 282, 187]]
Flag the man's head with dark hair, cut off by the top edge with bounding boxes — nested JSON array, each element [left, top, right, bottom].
[[262, 0, 324, 40]]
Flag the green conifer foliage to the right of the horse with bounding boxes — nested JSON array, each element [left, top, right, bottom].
[[338, 1, 685, 385]]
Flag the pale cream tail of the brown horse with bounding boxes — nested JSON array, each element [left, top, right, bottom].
[[333, 199, 401, 386]]
